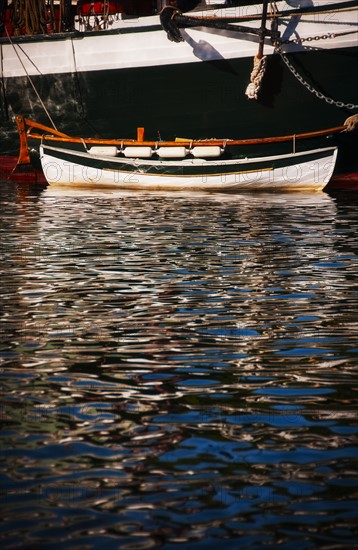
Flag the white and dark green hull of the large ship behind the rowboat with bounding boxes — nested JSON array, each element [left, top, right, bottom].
[[0, 0, 358, 172]]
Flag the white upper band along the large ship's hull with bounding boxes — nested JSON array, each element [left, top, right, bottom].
[[0, 0, 358, 78]]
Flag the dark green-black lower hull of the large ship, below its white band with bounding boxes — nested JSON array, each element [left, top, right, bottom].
[[0, 46, 358, 171]]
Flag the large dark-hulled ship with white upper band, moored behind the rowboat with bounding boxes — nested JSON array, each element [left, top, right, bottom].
[[0, 0, 358, 176]]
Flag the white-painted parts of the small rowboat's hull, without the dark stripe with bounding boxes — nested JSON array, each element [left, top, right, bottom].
[[40, 146, 337, 191]]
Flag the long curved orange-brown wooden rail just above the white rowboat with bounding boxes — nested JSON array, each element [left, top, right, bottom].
[[24, 119, 347, 147]]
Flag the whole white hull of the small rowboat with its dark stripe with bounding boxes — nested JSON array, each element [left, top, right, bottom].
[[40, 145, 337, 191]]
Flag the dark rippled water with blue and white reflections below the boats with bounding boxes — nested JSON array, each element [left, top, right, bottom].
[[0, 183, 358, 550]]
